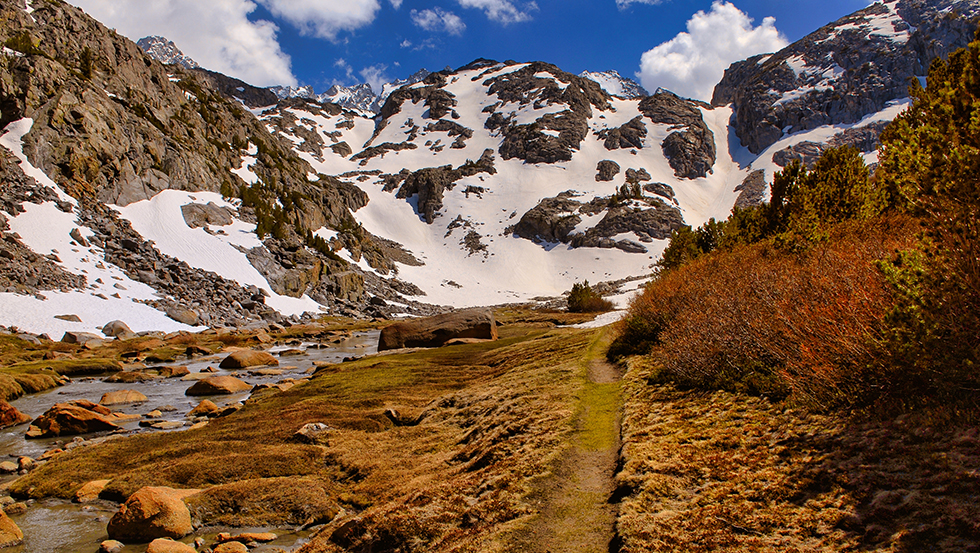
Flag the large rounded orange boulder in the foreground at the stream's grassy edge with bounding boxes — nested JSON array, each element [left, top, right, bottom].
[[106, 486, 199, 543]]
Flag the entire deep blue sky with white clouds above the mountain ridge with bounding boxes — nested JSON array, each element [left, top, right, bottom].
[[70, 0, 869, 97]]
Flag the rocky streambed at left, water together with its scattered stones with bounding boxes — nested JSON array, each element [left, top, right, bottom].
[[0, 331, 378, 553]]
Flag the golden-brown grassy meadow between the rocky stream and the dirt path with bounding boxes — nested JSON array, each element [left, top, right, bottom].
[[10, 322, 595, 552]]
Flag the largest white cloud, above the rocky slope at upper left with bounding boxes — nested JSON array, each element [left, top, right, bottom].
[[70, 0, 297, 86]]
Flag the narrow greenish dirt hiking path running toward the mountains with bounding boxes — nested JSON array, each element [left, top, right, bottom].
[[529, 330, 622, 553]]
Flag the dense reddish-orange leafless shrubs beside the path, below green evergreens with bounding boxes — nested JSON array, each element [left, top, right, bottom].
[[622, 218, 916, 408]]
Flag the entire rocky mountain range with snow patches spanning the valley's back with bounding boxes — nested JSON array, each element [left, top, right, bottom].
[[0, 0, 980, 332]]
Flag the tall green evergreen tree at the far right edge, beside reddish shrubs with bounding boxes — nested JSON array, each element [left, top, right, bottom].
[[879, 28, 980, 401]]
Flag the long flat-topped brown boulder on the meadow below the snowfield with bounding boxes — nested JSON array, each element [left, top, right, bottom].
[[378, 309, 497, 351]]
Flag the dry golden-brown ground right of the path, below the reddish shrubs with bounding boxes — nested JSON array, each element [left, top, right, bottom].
[[617, 359, 980, 553]]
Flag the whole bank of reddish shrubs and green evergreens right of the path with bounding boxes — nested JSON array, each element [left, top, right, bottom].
[[611, 30, 980, 410]]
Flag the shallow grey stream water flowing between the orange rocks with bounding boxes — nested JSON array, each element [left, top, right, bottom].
[[0, 331, 379, 553]]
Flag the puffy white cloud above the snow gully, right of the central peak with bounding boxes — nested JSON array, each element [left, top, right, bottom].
[[637, 0, 788, 100]]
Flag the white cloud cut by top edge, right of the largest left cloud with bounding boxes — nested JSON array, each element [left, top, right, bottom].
[[258, 0, 380, 40]]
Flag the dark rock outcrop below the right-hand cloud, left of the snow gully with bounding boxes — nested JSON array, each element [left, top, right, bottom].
[[639, 90, 717, 179]]
